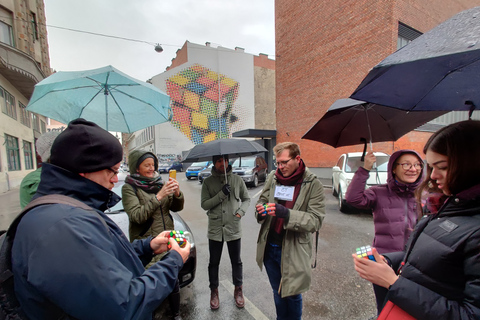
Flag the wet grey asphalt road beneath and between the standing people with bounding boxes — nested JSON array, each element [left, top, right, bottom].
[[155, 173, 375, 320]]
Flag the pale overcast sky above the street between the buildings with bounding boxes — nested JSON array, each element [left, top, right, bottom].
[[44, 0, 275, 81]]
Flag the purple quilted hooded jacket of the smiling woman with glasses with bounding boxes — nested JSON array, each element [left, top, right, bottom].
[[345, 150, 425, 253]]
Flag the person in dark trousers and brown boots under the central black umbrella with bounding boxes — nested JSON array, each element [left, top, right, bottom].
[[201, 156, 250, 310]]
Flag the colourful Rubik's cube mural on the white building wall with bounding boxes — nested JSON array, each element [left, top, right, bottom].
[[166, 64, 246, 145]]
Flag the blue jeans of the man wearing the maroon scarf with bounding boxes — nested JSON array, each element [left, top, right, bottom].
[[263, 243, 303, 320]]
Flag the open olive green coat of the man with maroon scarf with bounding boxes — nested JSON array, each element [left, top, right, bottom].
[[255, 168, 325, 297]]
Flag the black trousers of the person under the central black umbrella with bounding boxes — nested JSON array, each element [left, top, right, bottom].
[[208, 239, 243, 289]]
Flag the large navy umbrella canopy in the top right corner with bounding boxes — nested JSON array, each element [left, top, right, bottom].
[[351, 7, 480, 115]]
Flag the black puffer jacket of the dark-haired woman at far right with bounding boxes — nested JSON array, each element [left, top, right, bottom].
[[385, 185, 480, 320]]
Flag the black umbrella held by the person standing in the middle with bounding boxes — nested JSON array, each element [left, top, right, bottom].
[[182, 139, 268, 181]]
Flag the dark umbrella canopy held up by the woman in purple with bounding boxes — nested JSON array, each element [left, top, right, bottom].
[[302, 99, 447, 148]]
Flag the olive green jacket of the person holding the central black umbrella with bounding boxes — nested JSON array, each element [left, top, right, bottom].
[[201, 166, 250, 241]]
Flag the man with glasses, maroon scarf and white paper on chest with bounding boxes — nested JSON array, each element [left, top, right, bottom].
[[256, 142, 325, 320]]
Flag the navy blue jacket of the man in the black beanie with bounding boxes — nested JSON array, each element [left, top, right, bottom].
[[12, 164, 183, 320]]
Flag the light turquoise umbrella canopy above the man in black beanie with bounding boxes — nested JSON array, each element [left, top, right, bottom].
[[27, 66, 171, 133]]
